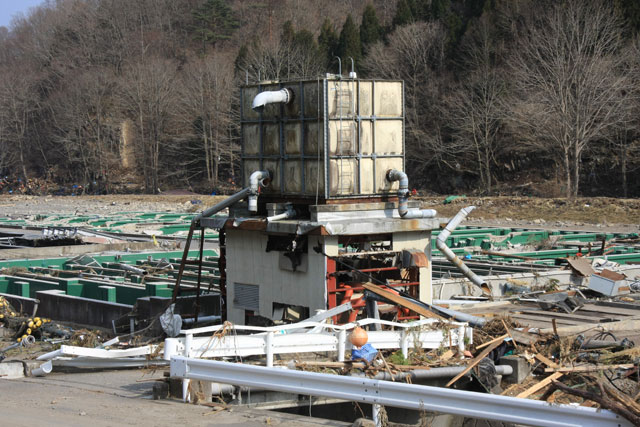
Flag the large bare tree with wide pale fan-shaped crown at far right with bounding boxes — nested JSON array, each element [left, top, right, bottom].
[[511, 0, 630, 197]]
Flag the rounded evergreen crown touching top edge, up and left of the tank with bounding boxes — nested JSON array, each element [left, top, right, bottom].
[[191, 0, 240, 53]]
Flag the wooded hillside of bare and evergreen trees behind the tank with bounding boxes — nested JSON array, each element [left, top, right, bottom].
[[0, 0, 640, 197]]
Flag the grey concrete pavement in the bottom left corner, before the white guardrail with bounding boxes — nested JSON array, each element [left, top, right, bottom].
[[0, 370, 351, 427]]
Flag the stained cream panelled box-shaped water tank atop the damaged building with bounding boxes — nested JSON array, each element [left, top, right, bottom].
[[241, 75, 404, 201]]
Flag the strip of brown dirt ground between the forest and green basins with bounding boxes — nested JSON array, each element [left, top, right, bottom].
[[0, 194, 640, 232]]
